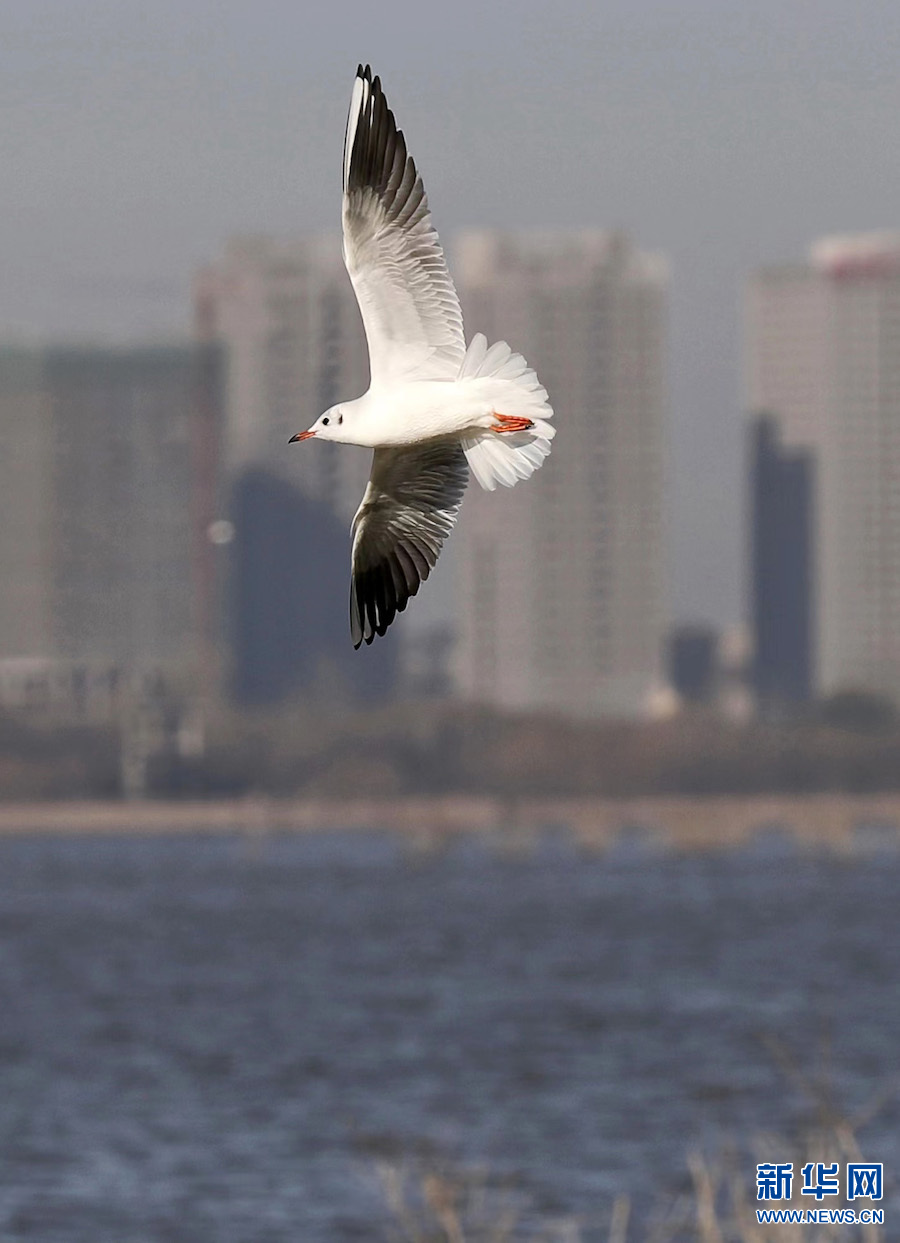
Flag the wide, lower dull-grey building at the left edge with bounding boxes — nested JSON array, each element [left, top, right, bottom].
[[0, 346, 217, 697]]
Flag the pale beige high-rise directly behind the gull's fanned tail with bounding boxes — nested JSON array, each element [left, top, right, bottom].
[[454, 232, 668, 715]]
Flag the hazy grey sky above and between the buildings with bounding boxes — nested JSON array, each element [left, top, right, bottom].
[[0, 0, 900, 622]]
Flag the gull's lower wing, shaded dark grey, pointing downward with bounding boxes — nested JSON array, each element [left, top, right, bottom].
[[351, 440, 469, 648]]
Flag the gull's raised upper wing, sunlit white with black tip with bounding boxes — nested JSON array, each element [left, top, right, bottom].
[[342, 65, 466, 387]]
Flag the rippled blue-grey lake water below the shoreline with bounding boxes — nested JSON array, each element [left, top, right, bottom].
[[0, 834, 900, 1243]]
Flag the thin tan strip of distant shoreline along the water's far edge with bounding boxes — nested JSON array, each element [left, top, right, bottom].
[[0, 794, 900, 853]]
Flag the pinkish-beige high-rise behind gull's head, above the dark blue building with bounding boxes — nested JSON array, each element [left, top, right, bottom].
[[195, 234, 372, 522]]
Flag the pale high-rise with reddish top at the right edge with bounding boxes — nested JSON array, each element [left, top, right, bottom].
[[746, 232, 900, 696]]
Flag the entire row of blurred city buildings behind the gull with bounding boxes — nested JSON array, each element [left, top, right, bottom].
[[0, 223, 900, 780]]
